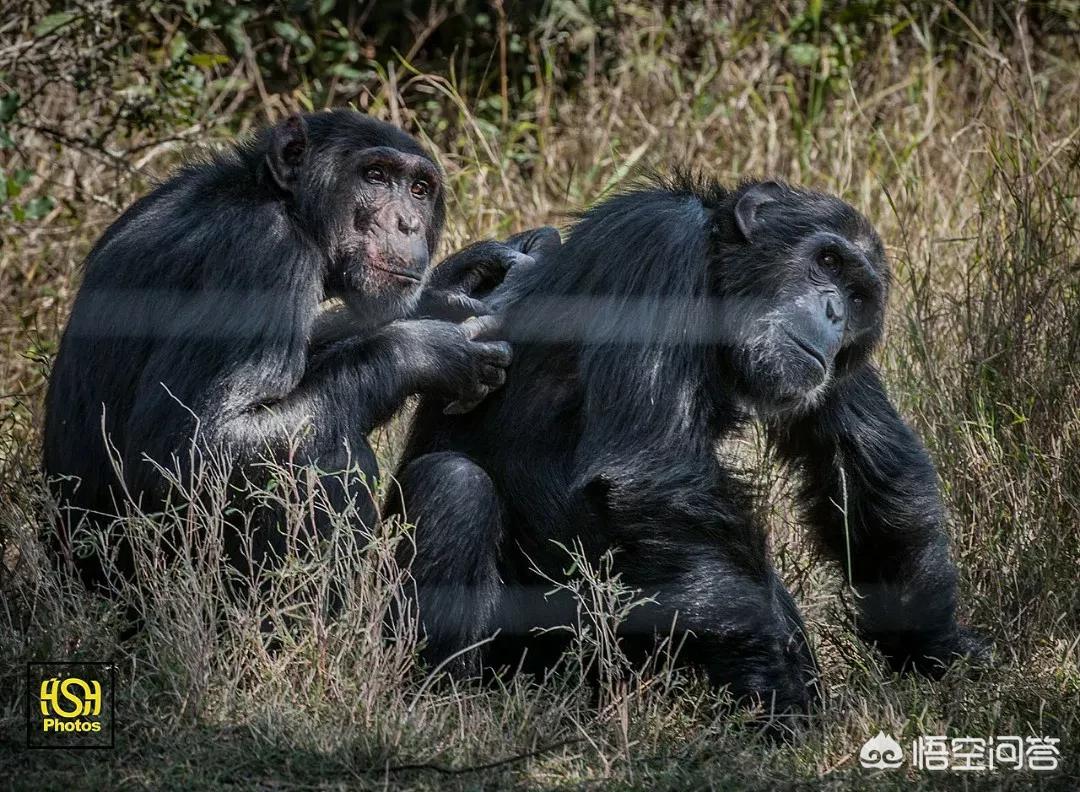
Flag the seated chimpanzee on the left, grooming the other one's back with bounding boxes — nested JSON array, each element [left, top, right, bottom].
[[44, 110, 523, 582]]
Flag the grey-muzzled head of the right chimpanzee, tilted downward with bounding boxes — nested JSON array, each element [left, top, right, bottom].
[[715, 182, 889, 412]]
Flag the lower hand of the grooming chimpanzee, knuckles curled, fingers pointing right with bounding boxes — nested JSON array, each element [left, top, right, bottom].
[[403, 317, 511, 415]]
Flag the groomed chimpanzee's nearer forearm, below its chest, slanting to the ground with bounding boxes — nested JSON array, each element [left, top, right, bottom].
[[585, 465, 816, 713]]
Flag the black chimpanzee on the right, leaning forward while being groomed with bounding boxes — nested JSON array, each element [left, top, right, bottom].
[[391, 178, 984, 711]]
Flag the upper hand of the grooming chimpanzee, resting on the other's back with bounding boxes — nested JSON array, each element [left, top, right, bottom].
[[414, 241, 532, 322]]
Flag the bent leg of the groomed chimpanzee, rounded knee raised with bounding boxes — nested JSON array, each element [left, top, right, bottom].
[[387, 453, 502, 677]]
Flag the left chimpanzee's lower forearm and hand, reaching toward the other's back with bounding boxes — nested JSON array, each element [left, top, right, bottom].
[[133, 320, 510, 466]]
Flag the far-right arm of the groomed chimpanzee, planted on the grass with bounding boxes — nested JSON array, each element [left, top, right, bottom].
[[770, 366, 978, 672]]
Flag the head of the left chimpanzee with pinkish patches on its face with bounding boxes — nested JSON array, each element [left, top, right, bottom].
[[265, 110, 445, 321]]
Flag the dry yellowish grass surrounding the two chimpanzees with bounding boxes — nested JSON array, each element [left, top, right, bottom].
[[0, 2, 1080, 789]]
